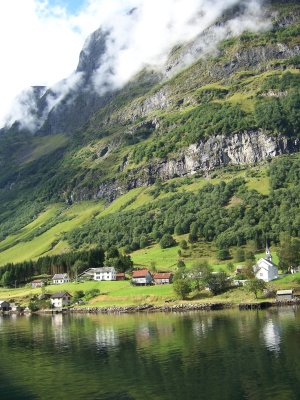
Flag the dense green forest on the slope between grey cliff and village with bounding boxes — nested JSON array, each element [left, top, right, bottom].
[[67, 158, 300, 259]]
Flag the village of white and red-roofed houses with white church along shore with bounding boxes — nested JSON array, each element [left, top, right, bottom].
[[0, 246, 300, 313]]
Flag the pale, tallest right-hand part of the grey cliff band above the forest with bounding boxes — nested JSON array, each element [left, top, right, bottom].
[[137, 131, 300, 180]]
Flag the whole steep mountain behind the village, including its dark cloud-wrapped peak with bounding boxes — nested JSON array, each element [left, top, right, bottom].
[[0, 1, 300, 264]]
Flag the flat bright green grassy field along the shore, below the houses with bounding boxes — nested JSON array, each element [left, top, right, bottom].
[[0, 273, 300, 307]]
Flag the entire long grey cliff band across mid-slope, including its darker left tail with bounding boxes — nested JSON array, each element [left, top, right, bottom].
[[73, 131, 300, 202]]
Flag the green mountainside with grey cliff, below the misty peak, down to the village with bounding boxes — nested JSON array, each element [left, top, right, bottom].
[[0, 1, 300, 276]]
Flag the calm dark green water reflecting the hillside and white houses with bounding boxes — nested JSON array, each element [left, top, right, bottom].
[[0, 308, 300, 400]]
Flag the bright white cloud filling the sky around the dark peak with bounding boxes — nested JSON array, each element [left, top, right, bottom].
[[0, 0, 268, 130]]
